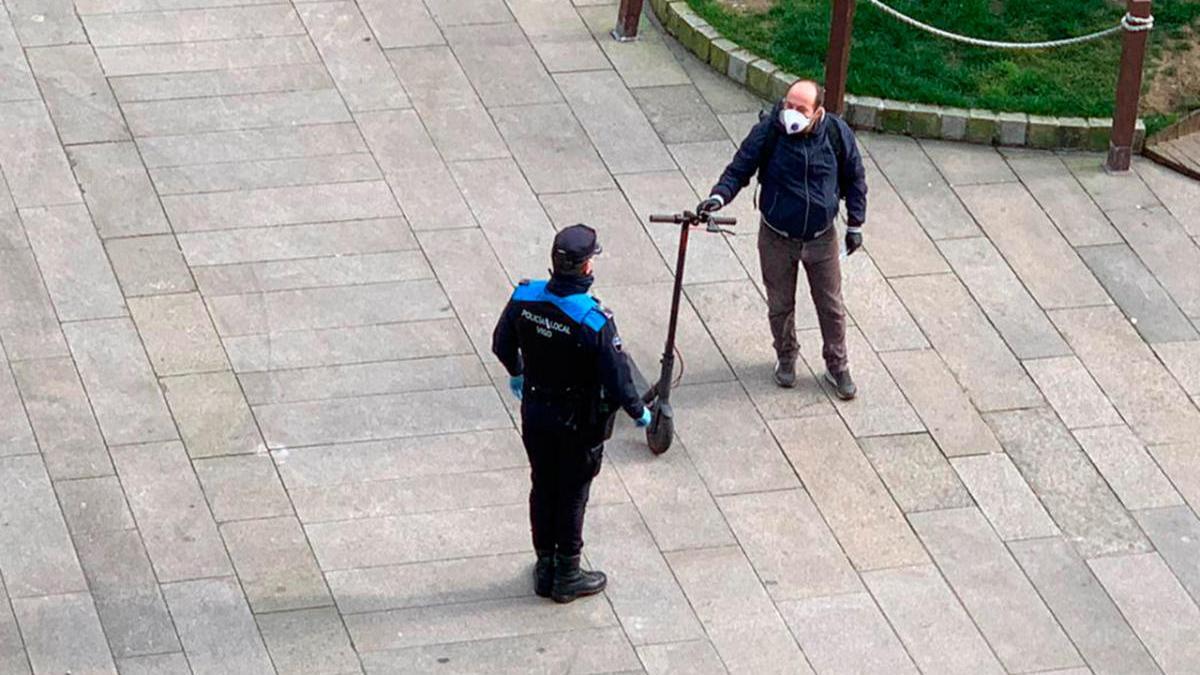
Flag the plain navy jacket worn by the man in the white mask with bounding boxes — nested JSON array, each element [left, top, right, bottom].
[[712, 102, 866, 240]]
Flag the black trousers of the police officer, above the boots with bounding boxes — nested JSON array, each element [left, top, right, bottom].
[[521, 411, 604, 556]]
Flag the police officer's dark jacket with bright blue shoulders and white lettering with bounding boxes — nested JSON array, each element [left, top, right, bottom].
[[492, 270, 644, 423]]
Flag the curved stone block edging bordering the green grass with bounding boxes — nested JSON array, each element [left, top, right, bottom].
[[650, 0, 1146, 151]]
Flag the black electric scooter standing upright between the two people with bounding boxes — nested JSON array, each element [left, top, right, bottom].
[[642, 211, 738, 455]]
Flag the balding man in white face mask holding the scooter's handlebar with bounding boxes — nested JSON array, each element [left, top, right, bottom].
[[700, 79, 866, 400]]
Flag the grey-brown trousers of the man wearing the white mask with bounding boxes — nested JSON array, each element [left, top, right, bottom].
[[758, 223, 847, 372]]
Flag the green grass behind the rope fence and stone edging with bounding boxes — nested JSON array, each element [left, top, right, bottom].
[[688, 0, 1200, 118]]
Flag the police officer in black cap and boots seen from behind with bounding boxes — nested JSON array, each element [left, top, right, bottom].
[[492, 225, 650, 603]]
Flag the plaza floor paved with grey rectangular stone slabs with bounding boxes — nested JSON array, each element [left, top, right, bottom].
[[0, 0, 1200, 675]]
